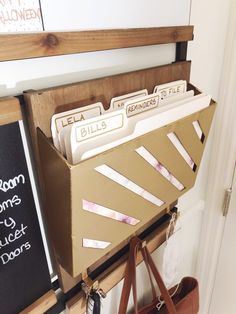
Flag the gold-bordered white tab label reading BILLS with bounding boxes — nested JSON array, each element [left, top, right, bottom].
[[76, 113, 124, 142]]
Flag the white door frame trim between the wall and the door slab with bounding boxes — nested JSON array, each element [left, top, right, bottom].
[[197, 4, 236, 314]]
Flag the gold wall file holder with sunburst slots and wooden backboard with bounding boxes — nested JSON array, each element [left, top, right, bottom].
[[25, 62, 215, 277]]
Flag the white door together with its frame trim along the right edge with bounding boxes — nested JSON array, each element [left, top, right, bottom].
[[197, 0, 236, 314]]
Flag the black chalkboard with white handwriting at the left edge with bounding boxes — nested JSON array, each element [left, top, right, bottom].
[[0, 103, 51, 314]]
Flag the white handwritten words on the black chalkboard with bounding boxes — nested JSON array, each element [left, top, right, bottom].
[[0, 174, 31, 265]]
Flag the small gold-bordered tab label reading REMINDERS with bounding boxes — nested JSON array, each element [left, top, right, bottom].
[[125, 94, 159, 117]]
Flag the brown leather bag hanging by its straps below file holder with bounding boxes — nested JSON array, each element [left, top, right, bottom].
[[118, 237, 199, 314]]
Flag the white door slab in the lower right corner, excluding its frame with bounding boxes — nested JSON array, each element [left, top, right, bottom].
[[209, 166, 236, 314]]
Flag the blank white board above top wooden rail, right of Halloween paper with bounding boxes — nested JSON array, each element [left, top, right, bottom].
[[41, 0, 190, 30]]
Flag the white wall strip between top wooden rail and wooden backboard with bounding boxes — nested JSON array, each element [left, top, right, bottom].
[[0, 45, 175, 96]]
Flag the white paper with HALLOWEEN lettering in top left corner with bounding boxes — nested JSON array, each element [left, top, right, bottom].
[[0, 0, 43, 32]]
